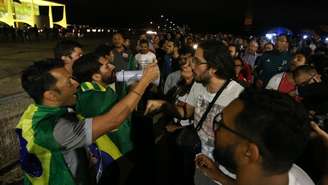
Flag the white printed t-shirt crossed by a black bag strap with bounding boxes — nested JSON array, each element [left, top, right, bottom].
[[187, 80, 244, 159]]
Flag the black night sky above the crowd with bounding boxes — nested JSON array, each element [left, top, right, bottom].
[[52, 0, 328, 31]]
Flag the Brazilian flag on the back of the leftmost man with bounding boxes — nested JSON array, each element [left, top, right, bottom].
[[16, 104, 75, 185]]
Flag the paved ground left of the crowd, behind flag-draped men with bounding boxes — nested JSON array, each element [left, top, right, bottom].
[[0, 39, 114, 184]]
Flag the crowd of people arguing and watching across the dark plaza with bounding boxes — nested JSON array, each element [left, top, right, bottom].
[[16, 29, 328, 185]]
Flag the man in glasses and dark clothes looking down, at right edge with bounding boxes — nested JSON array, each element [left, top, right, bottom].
[[294, 64, 328, 184]]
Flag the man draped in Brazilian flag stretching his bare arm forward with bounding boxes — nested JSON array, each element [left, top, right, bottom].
[[16, 59, 159, 185]]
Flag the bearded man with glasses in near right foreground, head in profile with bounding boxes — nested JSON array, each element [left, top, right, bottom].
[[196, 90, 314, 185]]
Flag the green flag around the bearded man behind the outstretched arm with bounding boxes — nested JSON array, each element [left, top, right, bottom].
[[76, 82, 133, 154]]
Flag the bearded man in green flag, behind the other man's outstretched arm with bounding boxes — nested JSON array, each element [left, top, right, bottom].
[[73, 45, 133, 154]]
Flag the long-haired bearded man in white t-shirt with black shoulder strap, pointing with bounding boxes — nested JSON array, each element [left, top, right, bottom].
[[145, 40, 244, 185]]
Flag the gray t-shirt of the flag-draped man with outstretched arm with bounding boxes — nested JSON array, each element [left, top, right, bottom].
[[53, 118, 92, 185]]
